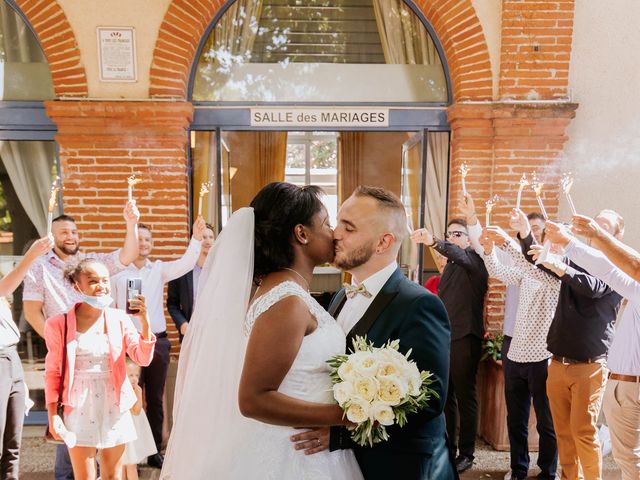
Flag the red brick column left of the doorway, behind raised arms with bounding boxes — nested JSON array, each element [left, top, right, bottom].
[[45, 101, 193, 348]]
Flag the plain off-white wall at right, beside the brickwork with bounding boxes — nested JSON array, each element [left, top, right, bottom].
[[561, 0, 640, 248]]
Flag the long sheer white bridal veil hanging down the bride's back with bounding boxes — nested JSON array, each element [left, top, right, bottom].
[[160, 208, 254, 480]]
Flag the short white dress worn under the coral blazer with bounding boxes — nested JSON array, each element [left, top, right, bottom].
[[65, 321, 137, 449]]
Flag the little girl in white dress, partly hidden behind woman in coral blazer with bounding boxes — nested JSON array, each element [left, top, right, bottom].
[[122, 359, 158, 480]]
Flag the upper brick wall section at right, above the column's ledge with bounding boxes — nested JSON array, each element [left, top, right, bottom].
[[499, 0, 574, 100]]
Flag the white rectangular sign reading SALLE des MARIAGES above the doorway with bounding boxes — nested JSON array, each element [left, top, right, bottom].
[[251, 107, 389, 128]]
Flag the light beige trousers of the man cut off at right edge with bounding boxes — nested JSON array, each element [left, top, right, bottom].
[[603, 380, 640, 480]]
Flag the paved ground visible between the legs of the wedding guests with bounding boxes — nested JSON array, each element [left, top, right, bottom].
[[20, 427, 620, 480]]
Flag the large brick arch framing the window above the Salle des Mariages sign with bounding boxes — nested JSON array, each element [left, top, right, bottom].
[[149, 0, 493, 102]]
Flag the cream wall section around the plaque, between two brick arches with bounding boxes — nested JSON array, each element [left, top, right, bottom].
[[58, 0, 171, 99]]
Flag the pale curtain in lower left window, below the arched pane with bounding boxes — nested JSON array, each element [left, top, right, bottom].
[[0, 141, 55, 236]]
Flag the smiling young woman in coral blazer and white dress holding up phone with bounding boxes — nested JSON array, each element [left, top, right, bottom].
[[44, 258, 156, 480]]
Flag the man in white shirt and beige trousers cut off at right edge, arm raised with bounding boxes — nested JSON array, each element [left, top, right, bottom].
[[547, 217, 640, 480]]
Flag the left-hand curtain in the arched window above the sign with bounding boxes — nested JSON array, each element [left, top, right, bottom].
[[204, 0, 262, 71]]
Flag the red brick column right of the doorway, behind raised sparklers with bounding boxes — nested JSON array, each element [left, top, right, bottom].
[[448, 103, 577, 330]]
